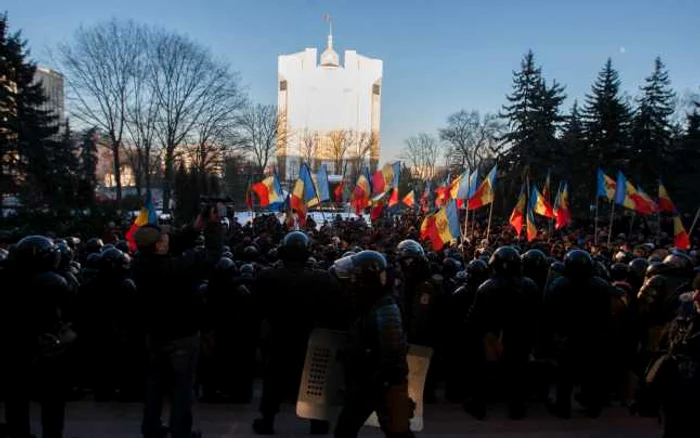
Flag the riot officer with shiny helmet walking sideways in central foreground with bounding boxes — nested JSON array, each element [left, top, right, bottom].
[[332, 251, 413, 438]]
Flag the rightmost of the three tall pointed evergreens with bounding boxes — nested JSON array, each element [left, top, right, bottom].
[[632, 58, 676, 182]]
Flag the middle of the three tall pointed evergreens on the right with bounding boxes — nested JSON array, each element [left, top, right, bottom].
[[583, 58, 631, 171]]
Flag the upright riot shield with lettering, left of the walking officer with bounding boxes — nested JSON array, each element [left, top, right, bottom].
[[296, 328, 348, 421]]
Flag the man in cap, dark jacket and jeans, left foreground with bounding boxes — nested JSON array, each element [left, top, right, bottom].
[[133, 225, 203, 438]]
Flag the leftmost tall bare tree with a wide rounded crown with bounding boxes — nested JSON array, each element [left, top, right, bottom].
[[59, 20, 145, 200]]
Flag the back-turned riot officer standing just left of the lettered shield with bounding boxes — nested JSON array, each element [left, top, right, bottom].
[[253, 231, 338, 435]]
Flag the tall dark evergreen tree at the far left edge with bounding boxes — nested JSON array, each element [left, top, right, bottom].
[[0, 15, 63, 207]]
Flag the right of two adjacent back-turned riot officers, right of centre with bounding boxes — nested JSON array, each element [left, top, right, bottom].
[[543, 250, 611, 418]]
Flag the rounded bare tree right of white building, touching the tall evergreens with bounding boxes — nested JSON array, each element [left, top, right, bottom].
[[439, 110, 506, 169]]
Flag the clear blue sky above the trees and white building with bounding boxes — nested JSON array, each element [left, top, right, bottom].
[[5, 0, 700, 161]]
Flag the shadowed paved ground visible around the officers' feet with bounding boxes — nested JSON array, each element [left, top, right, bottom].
[[9, 402, 661, 438]]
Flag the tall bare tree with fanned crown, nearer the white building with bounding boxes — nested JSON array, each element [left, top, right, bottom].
[[149, 31, 241, 211]]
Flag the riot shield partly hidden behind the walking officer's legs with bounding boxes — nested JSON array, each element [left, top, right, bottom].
[[365, 345, 433, 432]]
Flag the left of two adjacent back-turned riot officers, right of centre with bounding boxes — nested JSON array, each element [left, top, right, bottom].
[[465, 246, 540, 419]]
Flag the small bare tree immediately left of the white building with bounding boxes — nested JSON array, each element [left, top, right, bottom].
[[236, 103, 283, 174]]
